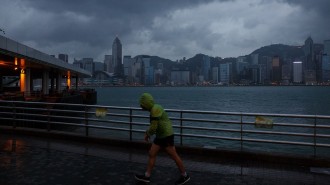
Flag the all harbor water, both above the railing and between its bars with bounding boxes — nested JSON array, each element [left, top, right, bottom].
[[87, 86, 330, 156]]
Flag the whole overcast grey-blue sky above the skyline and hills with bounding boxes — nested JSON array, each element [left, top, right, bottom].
[[0, 0, 330, 62]]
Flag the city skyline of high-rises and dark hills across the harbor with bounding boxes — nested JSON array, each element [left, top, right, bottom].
[[74, 37, 330, 85]]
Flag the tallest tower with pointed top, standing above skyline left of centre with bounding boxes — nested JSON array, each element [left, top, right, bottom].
[[112, 37, 124, 77]]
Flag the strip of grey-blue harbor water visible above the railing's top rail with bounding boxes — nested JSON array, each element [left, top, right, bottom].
[[96, 86, 330, 115]]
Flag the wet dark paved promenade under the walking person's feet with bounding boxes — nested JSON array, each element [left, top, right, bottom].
[[0, 131, 330, 185]]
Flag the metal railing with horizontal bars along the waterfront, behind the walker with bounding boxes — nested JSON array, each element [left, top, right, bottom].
[[0, 101, 330, 158]]
